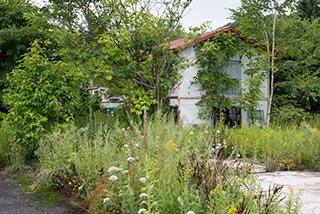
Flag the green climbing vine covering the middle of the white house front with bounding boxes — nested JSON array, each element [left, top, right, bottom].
[[195, 33, 239, 121]]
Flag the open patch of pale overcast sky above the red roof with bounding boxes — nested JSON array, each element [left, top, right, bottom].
[[182, 0, 240, 29]]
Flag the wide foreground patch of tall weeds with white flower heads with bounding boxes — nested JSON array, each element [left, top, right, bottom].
[[37, 115, 302, 213]]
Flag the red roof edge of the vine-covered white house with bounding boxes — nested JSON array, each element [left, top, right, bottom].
[[169, 26, 268, 52]]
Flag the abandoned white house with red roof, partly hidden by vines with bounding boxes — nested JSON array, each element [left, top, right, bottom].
[[169, 26, 269, 126]]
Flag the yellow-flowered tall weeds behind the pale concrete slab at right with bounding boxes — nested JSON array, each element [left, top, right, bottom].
[[229, 122, 320, 171]]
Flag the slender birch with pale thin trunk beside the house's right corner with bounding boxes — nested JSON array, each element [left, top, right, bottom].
[[231, 0, 293, 124]]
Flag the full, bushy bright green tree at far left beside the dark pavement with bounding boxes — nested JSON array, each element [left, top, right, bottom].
[[3, 40, 85, 158]]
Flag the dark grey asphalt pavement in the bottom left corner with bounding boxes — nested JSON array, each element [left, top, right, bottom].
[[0, 177, 84, 214]]
